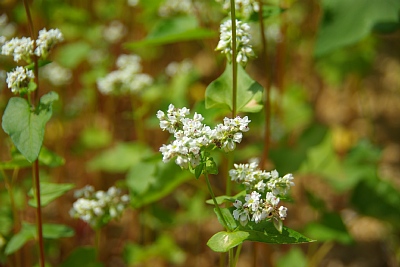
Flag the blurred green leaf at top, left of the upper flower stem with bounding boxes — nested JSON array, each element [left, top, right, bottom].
[[125, 16, 216, 49]]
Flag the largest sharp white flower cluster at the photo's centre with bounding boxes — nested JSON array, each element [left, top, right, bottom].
[[157, 104, 250, 169]]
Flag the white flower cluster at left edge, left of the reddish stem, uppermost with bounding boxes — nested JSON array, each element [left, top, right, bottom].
[[1, 37, 33, 63]]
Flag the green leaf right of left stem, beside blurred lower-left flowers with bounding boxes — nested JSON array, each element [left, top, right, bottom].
[[28, 182, 75, 208]]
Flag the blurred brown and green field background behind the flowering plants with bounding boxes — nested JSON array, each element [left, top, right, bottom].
[[0, 0, 400, 267]]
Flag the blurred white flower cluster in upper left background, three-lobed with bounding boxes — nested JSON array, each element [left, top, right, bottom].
[[97, 55, 153, 95]]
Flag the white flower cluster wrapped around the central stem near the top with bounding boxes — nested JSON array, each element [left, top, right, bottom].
[[215, 20, 255, 66]]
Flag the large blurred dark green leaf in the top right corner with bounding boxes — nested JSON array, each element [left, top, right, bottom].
[[314, 0, 400, 56]]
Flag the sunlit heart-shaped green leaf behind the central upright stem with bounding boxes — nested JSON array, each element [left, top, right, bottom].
[[206, 64, 264, 112]]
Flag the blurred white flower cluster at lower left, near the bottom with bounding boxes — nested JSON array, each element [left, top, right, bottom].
[[69, 185, 130, 228]]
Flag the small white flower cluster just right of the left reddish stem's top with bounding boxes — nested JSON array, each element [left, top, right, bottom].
[[35, 28, 64, 58]]
